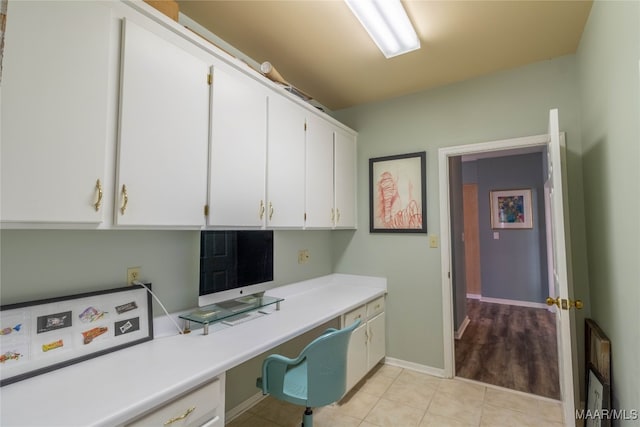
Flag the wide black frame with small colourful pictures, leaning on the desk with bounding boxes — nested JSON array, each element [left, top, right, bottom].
[[0, 283, 153, 387]]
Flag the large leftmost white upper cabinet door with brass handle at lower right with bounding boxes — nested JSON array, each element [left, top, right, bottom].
[[0, 1, 113, 224]]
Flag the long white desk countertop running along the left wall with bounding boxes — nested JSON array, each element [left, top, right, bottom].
[[0, 274, 387, 427]]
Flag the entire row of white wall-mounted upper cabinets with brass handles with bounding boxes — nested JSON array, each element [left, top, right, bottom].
[[0, 0, 356, 229]]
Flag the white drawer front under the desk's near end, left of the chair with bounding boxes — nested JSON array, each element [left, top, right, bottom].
[[125, 373, 225, 427]]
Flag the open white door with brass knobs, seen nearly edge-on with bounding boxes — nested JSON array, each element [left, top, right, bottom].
[[547, 109, 575, 425]]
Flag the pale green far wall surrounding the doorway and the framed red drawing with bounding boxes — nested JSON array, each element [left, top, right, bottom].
[[332, 55, 588, 374]]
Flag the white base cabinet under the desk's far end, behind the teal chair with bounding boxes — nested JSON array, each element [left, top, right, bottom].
[[341, 296, 386, 391]]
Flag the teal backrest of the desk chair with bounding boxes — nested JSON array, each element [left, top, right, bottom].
[[300, 319, 360, 407]]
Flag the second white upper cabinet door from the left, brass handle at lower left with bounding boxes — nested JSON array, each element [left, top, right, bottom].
[[116, 20, 209, 226]]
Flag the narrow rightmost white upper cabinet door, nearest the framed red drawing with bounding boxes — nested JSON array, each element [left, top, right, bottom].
[[334, 130, 357, 228]]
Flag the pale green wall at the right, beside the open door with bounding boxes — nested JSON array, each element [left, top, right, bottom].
[[577, 1, 640, 416]]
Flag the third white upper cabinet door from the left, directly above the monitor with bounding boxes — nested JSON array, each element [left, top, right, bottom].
[[208, 67, 267, 227]]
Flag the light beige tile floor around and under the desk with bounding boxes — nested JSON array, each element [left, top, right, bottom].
[[227, 365, 564, 427]]
